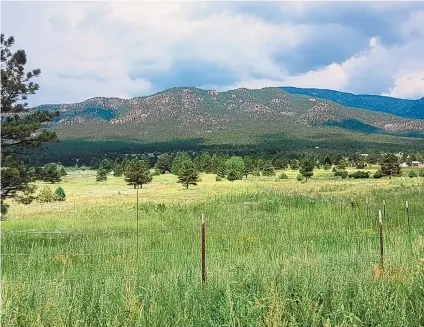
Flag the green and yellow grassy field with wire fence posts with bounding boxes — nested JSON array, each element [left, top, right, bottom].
[[1, 170, 424, 327]]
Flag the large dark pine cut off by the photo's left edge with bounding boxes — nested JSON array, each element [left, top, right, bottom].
[[1, 34, 59, 215]]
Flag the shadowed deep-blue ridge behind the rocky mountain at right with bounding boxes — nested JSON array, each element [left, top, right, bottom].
[[282, 86, 424, 119]]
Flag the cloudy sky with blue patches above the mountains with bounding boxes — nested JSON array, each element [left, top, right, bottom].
[[1, 1, 424, 105]]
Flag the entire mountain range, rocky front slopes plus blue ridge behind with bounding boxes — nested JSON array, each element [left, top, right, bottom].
[[33, 87, 424, 154]]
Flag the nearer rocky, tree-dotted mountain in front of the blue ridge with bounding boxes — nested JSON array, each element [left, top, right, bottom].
[[34, 87, 424, 164]]
